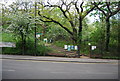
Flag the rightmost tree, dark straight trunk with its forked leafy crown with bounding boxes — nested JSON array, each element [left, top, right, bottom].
[[94, 1, 120, 51]]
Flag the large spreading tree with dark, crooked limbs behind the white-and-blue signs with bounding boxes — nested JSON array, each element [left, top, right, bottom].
[[38, 0, 98, 57]]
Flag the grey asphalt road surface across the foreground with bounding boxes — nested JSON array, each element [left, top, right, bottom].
[[2, 59, 118, 79]]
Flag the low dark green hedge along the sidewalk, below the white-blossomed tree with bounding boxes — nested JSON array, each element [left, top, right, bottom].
[[2, 40, 51, 56]]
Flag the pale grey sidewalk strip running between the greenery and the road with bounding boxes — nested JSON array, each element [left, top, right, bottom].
[[0, 55, 118, 63]]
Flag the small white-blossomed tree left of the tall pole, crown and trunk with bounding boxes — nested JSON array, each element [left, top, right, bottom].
[[8, 2, 34, 55]]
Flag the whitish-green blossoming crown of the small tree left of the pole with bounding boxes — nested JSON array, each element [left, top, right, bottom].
[[8, 13, 33, 37]]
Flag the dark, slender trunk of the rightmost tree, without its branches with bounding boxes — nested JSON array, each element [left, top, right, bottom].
[[105, 18, 110, 51]]
